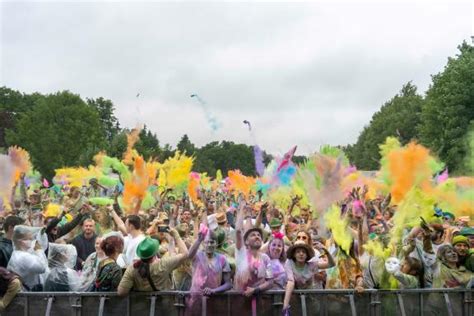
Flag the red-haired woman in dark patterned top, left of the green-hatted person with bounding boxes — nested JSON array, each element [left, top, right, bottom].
[[94, 233, 124, 292]]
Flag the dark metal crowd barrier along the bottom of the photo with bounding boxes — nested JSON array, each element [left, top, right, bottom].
[[1, 289, 474, 316]]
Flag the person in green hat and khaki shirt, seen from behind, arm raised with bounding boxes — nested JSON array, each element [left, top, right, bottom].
[[117, 229, 202, 296]]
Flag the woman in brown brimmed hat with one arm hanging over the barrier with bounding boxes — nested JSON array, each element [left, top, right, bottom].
[[283, 241, 334, 311]]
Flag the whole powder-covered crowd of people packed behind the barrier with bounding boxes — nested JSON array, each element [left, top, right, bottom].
[[0, 141, 474, 311]]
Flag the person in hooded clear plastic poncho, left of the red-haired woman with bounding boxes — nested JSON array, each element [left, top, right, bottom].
[[44, 243, 80, 292]]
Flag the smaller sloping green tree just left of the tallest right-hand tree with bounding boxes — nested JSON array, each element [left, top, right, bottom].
[[346, 82, 423, 170]]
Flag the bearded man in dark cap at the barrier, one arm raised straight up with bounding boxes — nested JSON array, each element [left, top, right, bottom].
[[235, 227, 273, 297]]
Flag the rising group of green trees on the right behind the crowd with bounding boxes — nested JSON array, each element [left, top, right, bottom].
[[344, 42, 474, 175]]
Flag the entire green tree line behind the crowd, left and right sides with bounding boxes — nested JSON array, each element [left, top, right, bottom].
[[0, 42, 474, 178]]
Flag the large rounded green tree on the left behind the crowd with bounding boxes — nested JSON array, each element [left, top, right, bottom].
[[6, 91, 105, 178]]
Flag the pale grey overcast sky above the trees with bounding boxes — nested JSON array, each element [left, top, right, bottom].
[[0, 1, 474, 154]]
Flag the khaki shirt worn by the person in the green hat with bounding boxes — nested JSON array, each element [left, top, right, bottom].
[[119, 254, 184, 292]]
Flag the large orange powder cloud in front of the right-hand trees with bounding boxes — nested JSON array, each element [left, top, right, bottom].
[[387, 142, 441, 203]]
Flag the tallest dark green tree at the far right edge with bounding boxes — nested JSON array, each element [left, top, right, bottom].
[[419, 42, 474, 173]]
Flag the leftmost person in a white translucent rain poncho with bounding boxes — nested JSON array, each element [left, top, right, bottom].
[[7, 225, 48, 292]]
